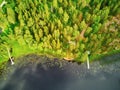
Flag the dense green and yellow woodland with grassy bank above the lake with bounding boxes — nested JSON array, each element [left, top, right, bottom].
[[0, 0, 120, 62]]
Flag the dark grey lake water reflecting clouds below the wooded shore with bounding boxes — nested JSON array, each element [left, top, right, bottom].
[[0, 55, 120, 90]]
